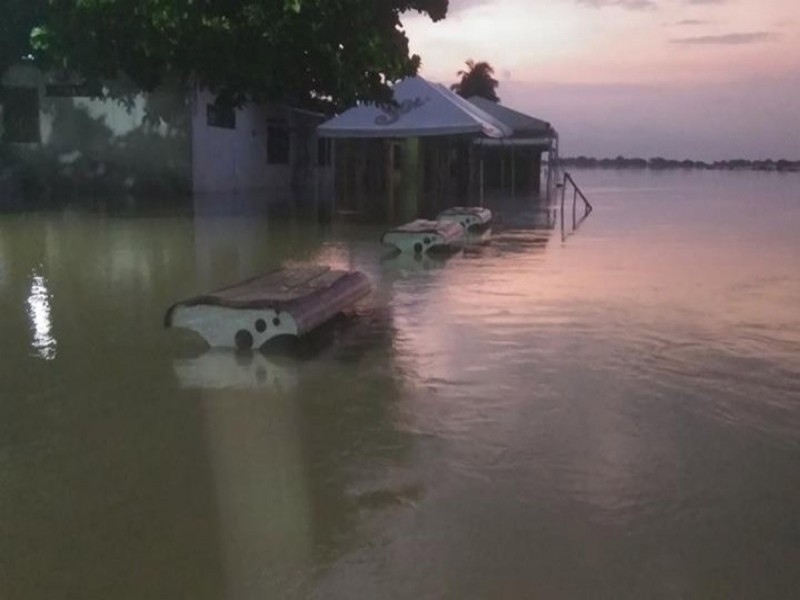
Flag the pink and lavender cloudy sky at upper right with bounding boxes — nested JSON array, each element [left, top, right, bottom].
[[404, 0, 800, 160]]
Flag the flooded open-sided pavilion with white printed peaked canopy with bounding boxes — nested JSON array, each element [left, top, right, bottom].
[[317, 77, 558, 219]]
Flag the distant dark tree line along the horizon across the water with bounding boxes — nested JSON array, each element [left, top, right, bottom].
[[559, 156, 800, 171]]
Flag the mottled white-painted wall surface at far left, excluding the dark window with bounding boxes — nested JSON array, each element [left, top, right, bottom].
[[0, 64, 191, 194]]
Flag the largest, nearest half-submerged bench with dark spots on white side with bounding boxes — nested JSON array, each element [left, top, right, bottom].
[[164, 266, 372, 350]]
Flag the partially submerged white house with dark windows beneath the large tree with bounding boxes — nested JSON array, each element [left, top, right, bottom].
[[0, 64, 329, 204]]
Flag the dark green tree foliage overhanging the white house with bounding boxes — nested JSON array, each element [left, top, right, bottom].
[[0, 0, 448, 108]]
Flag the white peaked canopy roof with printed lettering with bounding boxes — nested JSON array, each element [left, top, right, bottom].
[[317, 77, 513, 139]]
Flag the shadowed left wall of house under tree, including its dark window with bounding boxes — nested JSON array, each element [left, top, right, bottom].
[[0, 65, 191, 197]]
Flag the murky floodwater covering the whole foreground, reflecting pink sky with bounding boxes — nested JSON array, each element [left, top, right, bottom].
[[0, 171, 800, 600]]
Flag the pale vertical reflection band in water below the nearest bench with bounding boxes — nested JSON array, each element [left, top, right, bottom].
[[200, 391, 314, 599]]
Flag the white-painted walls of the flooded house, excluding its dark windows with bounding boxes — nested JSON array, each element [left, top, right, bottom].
[[0, 64, 330, 199]]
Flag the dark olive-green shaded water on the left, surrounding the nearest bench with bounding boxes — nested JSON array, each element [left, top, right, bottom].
[[0, 209, 419, 599]]
